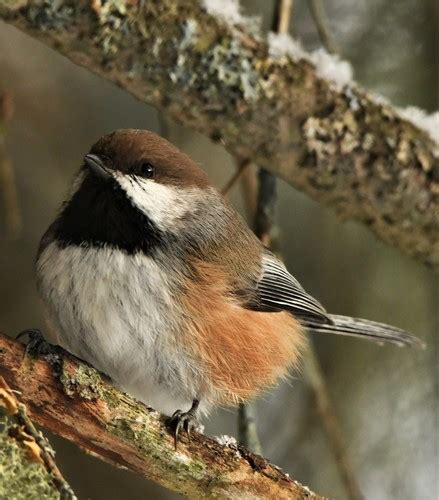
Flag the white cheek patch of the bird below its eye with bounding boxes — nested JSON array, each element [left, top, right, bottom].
[[115, 174, 200, 230]]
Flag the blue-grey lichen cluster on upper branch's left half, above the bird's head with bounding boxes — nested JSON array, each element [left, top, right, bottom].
[[92, 0, 262, 109]]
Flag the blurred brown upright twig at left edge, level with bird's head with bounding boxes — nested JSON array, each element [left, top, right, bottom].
[[0, 92, 22, 238]]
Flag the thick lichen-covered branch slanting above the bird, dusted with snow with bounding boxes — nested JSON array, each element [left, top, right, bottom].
[[0, 0, 439, 265]]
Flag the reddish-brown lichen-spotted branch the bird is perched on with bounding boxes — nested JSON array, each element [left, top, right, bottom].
[[0, 334, 320, 499]]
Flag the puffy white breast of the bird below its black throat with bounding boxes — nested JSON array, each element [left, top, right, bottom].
[[37, 242, 204, 413]]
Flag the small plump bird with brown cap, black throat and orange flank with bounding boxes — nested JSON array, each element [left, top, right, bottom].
[[36, 129, 420, 438]]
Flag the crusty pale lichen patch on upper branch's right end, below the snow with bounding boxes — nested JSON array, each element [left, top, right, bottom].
[[302, 89, 437, 184]]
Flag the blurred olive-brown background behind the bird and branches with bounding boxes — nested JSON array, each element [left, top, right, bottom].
[[0, 0, 439, 500]]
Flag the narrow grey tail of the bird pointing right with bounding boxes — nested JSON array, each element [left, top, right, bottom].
[[305, 314, 425, 348]]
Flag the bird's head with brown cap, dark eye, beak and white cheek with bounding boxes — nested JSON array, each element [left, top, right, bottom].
[[84, 129, 213, 229]]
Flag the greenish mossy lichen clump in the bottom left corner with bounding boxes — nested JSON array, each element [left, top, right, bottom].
[[0, 418, 60, 500]]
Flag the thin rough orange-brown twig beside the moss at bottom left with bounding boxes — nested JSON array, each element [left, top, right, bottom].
[[0, 376, 77, 500]]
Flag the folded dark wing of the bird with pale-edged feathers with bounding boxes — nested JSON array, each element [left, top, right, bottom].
[[249, 250, 331, 324]]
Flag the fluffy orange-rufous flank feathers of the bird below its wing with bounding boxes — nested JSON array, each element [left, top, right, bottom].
[[182, 262, 304, 404]]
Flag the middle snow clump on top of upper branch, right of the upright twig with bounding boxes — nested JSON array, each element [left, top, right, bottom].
[[268, 33, 353, 90]]
